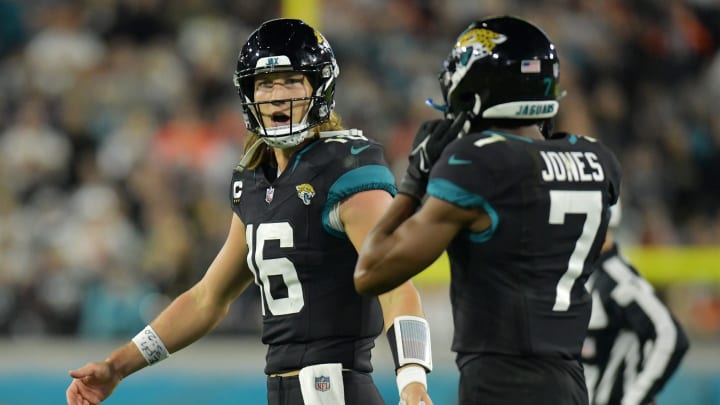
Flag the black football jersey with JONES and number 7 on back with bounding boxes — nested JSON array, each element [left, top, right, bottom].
[[428, 131, 620, 362]]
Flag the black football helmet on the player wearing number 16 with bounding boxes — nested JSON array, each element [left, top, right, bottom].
[[233, 18, 340, 148]]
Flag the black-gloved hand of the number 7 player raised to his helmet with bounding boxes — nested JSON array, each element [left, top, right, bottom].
[[398, 112, 467, 201]]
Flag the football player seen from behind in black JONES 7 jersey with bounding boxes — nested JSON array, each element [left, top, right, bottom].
[[355, 16, 620, 405]]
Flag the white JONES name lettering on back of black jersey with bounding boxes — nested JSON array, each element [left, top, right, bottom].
[[540, 151, 605, 182]]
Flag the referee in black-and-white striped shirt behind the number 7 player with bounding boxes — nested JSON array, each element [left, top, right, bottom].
[[582, 202, 689, 405]]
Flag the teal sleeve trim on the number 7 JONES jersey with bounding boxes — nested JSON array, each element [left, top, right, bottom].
[[427, 179, 500, 243]]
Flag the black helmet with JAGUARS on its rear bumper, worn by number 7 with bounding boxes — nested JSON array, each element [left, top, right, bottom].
[[439, 16, 560, 133]]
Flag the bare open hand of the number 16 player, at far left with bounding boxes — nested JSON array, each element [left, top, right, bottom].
[[65, 361, 122, 405]]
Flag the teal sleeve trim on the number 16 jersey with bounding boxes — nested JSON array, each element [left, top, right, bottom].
[[322, 165, 397, 239]]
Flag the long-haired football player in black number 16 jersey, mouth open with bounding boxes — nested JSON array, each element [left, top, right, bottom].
[[67, 19, 432, 405]]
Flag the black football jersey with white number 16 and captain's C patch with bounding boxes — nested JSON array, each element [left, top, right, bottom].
[[230, 131, 396, 374]]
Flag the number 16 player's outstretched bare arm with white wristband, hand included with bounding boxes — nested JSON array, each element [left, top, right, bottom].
[[66, 215, 252, 405]]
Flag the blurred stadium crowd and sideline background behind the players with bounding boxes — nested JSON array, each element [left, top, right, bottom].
[[0, 0, 720, 405]]
